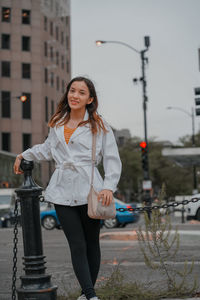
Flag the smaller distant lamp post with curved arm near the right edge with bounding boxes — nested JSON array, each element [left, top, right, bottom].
[[167, 106, 197, 194]]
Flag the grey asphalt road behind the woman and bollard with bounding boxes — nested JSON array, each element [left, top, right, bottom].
[[0, 220, 200, 300]]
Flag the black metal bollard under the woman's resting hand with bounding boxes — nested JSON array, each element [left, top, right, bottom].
[[16, 159, 57, 300]]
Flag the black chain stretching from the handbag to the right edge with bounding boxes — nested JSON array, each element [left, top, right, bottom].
[[116, 198, 200, 213]]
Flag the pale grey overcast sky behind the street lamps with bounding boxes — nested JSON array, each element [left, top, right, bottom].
[[71, 0, 200, 142]]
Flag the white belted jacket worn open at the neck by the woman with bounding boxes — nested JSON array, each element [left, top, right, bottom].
[[22, 110, 121, 206]]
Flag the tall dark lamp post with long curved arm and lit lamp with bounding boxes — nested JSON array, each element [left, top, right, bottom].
[[96, 36, 151, 204]]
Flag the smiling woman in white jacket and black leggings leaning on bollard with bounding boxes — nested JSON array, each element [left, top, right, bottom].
[[14, 77, 121, 300]]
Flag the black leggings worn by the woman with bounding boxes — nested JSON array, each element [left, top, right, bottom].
[[55, 204, 101, 299]]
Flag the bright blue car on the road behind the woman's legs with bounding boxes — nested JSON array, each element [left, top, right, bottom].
[[40, 198, 140, 230]]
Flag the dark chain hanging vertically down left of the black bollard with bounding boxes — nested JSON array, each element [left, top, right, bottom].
[[12, 198, 19, 300]]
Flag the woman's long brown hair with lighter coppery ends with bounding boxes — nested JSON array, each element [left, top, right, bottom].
[[48, 76, 107, 134]]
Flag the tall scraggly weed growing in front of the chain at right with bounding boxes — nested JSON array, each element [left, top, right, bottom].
[[137, 186, 197, 296]]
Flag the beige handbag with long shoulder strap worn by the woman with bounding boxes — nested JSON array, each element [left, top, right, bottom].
[[87, 134, 116, 219]]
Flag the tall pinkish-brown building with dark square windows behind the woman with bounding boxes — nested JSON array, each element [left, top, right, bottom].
[[0, 0, 71, 186]]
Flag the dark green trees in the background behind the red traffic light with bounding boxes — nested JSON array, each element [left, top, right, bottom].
[[115, 133, 200, 200]]
